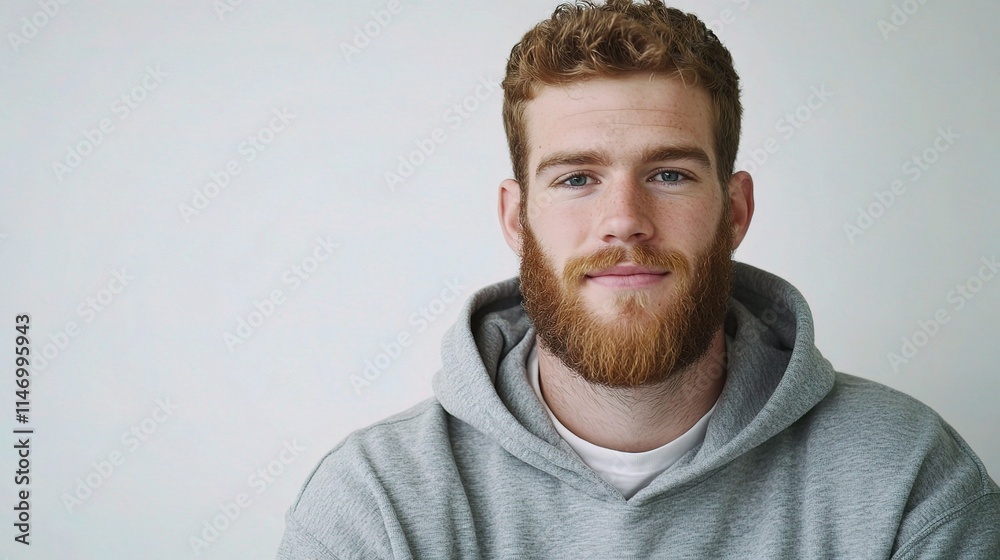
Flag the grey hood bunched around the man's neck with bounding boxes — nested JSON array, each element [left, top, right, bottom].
[[433, 263, 835, 503]]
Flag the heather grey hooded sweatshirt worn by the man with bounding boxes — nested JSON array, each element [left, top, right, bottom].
[[278, 264, 1000, 560]]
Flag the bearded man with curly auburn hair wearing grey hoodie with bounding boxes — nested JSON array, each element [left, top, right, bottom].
[[278, 0, 1000, 559]]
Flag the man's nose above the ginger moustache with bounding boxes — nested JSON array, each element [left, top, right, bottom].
[[598, 179, 654, 245]]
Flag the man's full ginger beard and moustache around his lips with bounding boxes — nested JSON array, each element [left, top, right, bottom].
[[521, 211, 733, 387]]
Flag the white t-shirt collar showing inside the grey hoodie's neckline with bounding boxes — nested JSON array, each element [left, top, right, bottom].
[[527, 343, 718, 499]]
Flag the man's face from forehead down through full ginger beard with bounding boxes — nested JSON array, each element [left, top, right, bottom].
[[501, 74, 749, 387]]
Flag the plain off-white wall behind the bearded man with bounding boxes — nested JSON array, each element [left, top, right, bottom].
[[0, 0, 1000, 559]]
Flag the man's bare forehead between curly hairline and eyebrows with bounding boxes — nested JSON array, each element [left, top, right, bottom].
[[525, 73, 715, 172]]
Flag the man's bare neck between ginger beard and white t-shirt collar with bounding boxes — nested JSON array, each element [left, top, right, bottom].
[[538, 328, 726, 453]]
